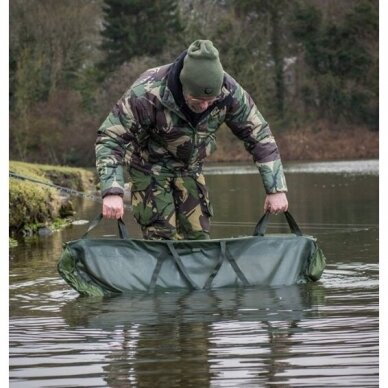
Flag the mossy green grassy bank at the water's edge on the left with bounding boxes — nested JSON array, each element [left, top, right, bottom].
[[9, 161, 95, 237]]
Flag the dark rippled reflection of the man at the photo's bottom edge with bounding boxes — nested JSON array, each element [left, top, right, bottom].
[[102, 322, 211, 388]]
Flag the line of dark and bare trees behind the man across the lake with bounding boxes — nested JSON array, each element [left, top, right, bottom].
[[9, 0, 379, 166]]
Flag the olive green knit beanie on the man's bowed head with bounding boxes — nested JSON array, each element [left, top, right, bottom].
[[179, 40, 224, 97]]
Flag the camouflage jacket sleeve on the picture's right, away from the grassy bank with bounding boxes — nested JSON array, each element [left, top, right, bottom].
[[225, 82, 287, 194]]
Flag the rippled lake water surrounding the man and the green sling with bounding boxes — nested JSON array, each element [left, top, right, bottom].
[[9, 161, 379, 388]]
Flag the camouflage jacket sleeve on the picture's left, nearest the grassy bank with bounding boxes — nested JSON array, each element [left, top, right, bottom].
[[95, 93, 139, 197]]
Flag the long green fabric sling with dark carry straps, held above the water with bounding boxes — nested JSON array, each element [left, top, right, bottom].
[[58, 212, 326, 296]]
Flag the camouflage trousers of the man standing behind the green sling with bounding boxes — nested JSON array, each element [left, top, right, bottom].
[[130, 168, 213, 240]]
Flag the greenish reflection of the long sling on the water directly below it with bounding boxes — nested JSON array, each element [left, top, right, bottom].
[[62, 285, 324, 329]]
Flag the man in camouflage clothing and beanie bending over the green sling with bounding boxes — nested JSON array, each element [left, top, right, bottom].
[[96, 40, 288, 239]]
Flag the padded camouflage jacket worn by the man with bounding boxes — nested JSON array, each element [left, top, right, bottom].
[[96, 52, 287, 197]]
